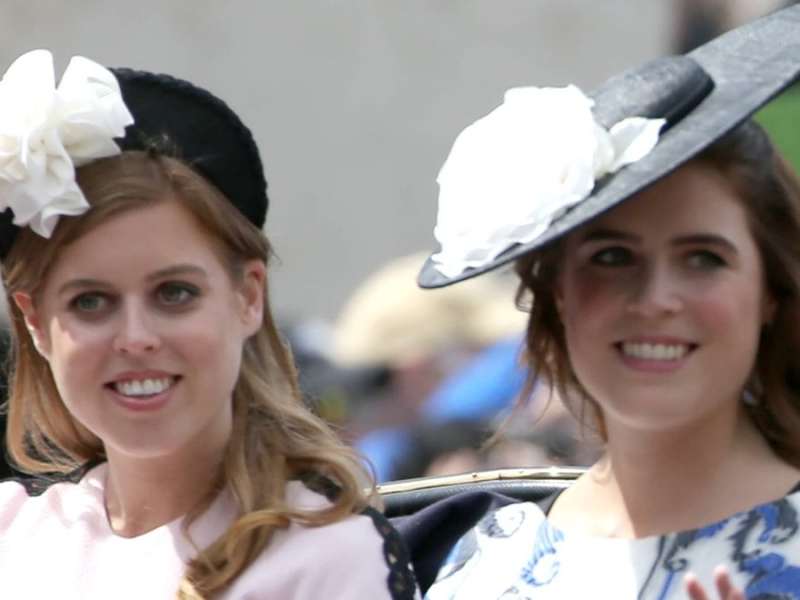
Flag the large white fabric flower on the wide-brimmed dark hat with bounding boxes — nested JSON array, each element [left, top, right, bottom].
[[432, 85, 665, 277]]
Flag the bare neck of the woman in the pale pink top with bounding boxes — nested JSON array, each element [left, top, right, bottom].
[[105, 434, 225, 537]]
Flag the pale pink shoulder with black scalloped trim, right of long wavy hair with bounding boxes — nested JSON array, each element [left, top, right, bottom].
[[227, 483, 417, 600]]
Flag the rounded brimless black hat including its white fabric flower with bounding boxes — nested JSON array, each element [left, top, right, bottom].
[[0, 56, 269, 259]]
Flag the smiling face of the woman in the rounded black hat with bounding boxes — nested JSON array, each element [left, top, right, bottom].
[[15, 201, 265, 458]]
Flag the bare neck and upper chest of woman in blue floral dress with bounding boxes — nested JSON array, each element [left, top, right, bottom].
[[554, 411, 800, 538]]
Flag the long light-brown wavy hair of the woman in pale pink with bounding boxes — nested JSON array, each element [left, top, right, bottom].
[[3, 152, 371, 599]]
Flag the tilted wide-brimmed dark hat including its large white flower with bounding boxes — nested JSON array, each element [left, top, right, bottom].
[[418, 6, 800, 288]]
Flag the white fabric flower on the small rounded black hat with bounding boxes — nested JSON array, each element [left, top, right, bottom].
[[0, 50, 133, 237]]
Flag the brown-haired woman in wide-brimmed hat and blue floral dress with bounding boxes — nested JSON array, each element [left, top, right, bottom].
[[420, 8, 800, 600]]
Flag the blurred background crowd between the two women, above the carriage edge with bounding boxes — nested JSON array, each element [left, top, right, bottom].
[[286, 253, 597, 481]]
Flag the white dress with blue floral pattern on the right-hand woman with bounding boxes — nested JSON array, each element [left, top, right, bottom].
[[426, 492, 800, 600]]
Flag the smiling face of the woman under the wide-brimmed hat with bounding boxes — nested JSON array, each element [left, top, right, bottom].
[[556, 163, 773, 431]]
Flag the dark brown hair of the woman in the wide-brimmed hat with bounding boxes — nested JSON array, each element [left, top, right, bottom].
[[515, 120, 800, 466]]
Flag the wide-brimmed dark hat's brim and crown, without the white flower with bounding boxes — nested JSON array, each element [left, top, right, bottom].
[[418, 6, 800, 288]]
